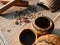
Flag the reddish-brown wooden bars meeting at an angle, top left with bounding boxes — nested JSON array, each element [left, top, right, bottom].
[[0, 0, 28, 13]]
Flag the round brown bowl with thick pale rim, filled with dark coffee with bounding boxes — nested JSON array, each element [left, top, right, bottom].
[[32, 16, 54, 35]]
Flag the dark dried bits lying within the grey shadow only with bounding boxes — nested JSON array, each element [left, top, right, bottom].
[[14, 5, 40, 17]]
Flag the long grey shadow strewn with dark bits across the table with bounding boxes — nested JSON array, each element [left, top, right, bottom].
[[2, 5, 46, 19]]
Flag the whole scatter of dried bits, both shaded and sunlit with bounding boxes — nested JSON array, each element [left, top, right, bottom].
[[14, 5, 40, 25]]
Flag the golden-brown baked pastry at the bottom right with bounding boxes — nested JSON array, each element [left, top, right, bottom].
[[35, 34, 60, 45]]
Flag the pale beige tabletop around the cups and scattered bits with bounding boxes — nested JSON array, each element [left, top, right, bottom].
[[0, 0, 60, 45]]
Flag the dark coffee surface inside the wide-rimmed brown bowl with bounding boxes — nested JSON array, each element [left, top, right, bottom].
[[35, 17, 50, 28]]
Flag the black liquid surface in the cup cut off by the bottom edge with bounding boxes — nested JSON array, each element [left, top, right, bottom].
[[19, 29, 36, 45]]
